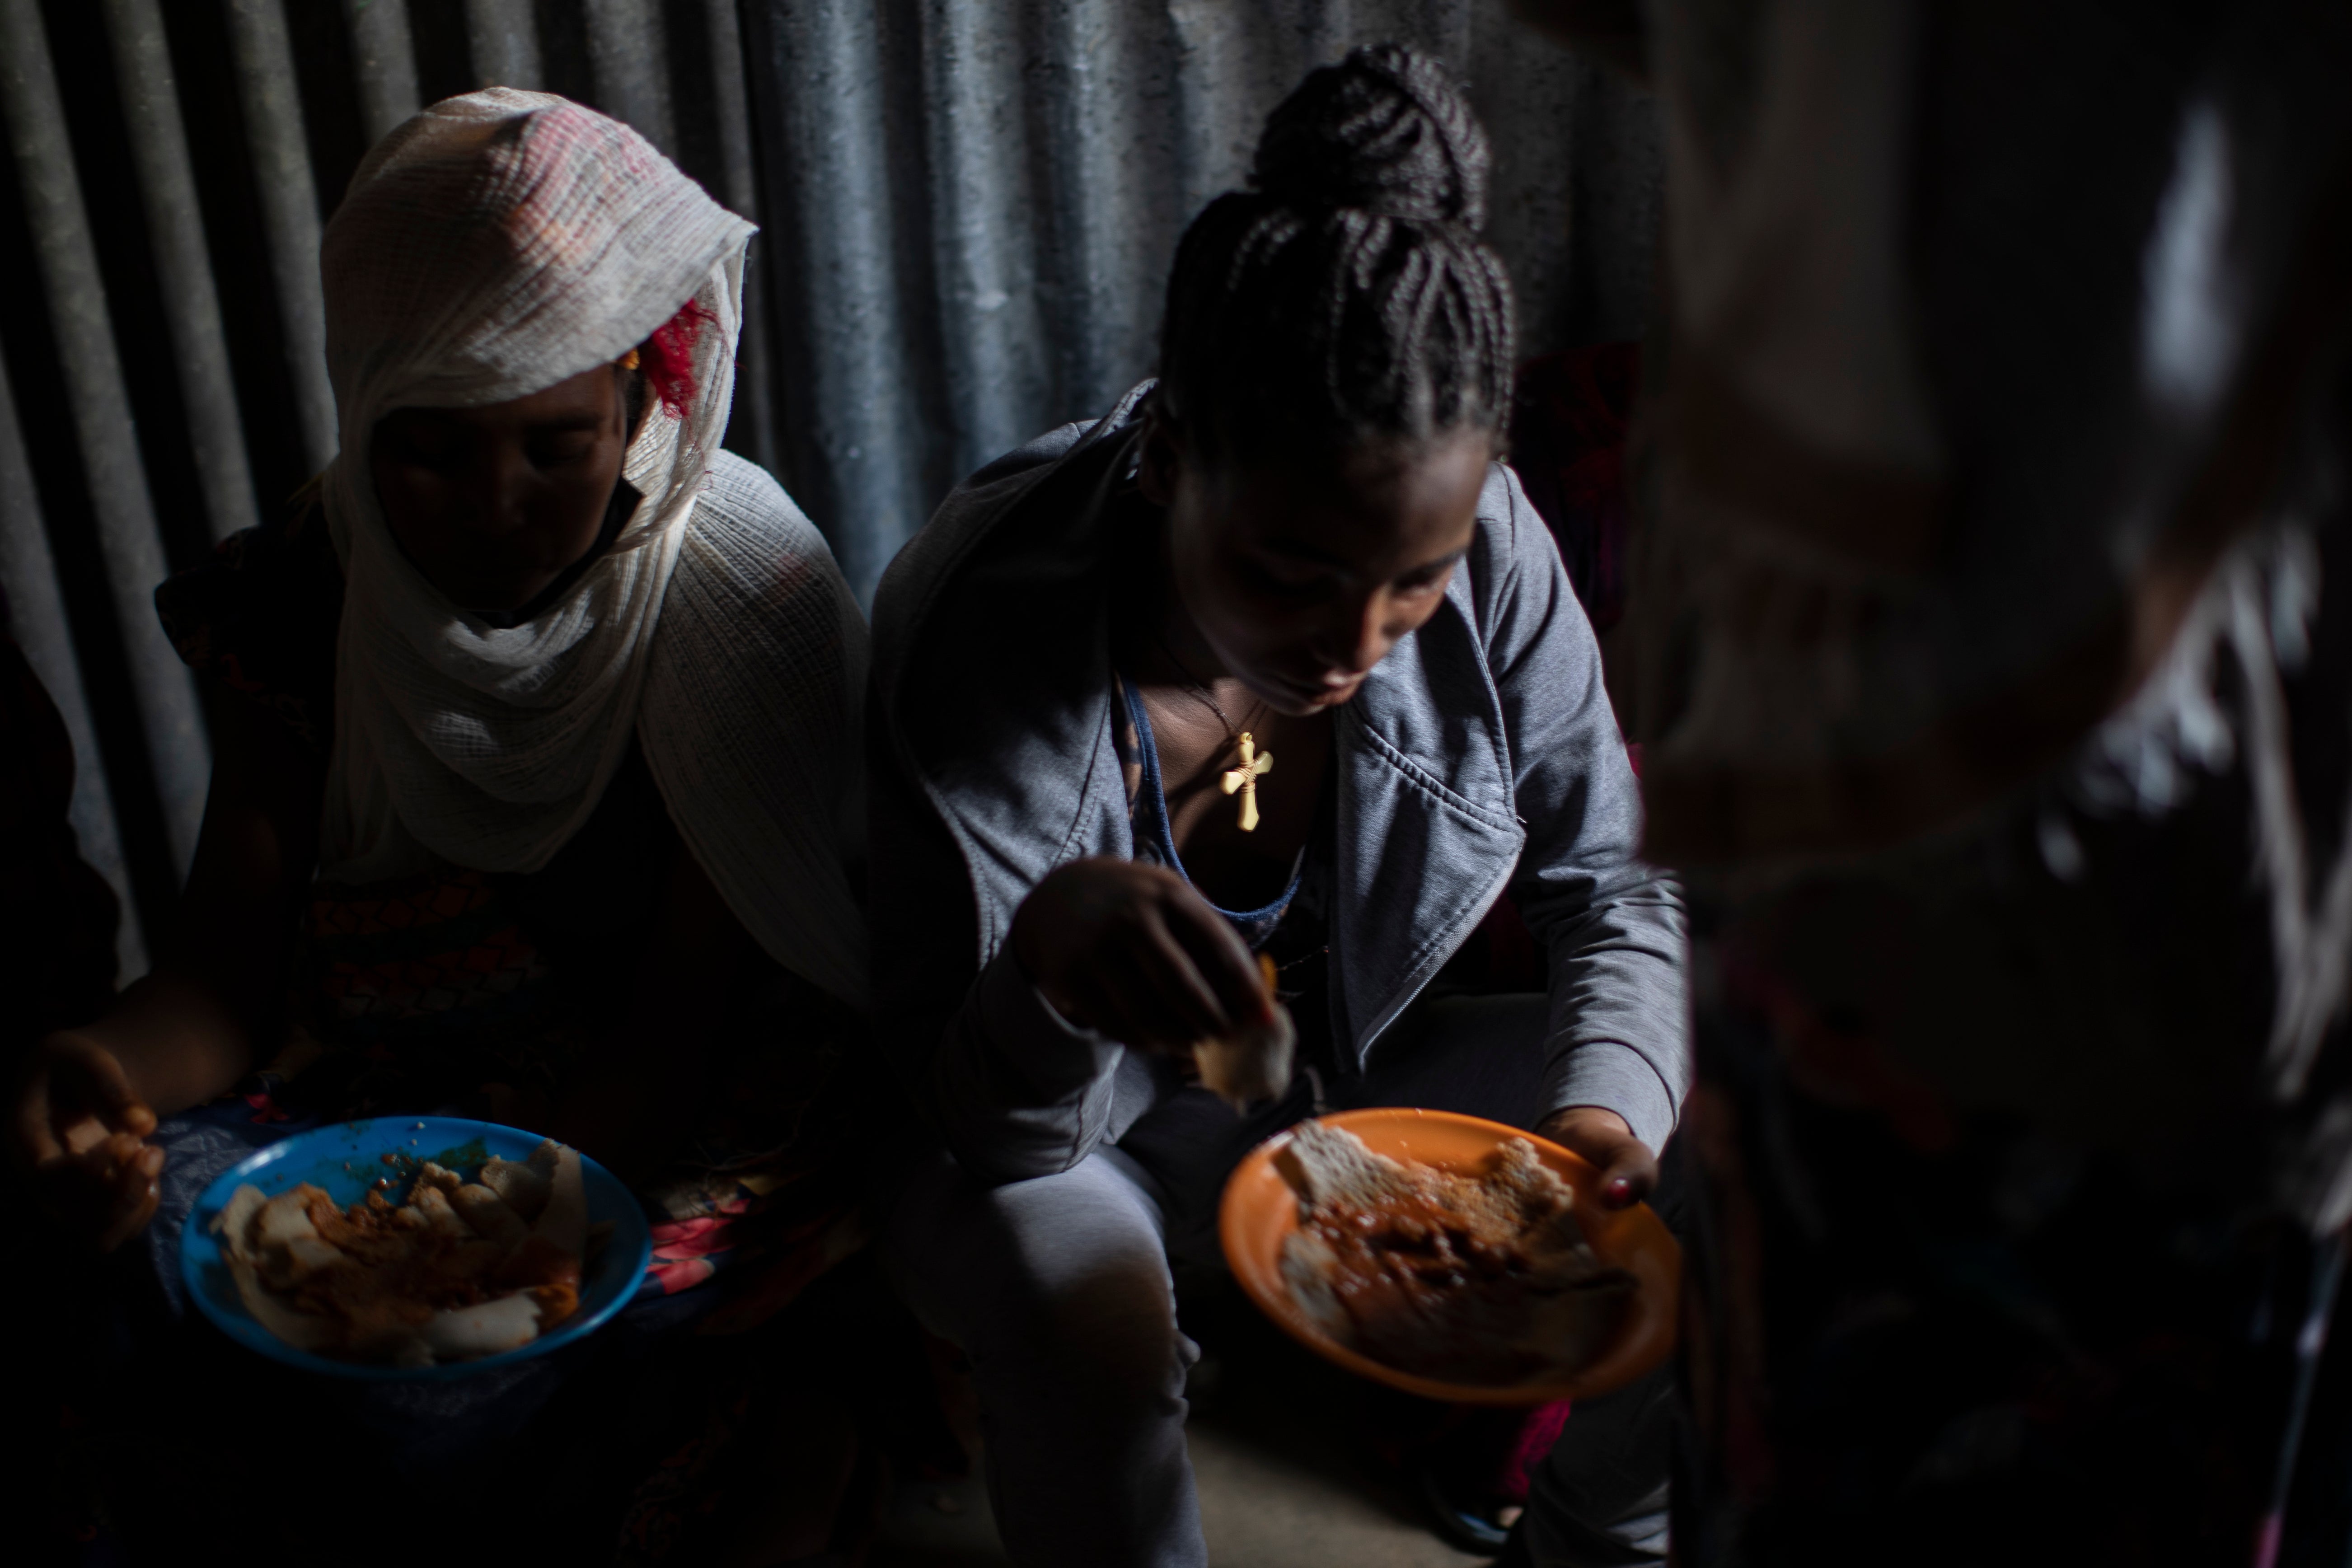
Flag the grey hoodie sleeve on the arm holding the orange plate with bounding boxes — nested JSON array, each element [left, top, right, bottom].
[[1472, 463, 1691, 1150]]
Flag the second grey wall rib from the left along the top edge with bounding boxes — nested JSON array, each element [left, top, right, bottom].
[[106, 0, 259, 550]]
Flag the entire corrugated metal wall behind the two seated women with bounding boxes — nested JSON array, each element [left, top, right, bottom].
[[0, 0, 1658, 976]]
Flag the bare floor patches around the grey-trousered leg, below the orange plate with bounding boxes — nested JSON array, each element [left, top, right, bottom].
[[868, 1288, 1484, 1568]]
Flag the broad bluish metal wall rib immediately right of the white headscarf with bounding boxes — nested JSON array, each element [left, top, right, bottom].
[[755, 0, 929, 604]]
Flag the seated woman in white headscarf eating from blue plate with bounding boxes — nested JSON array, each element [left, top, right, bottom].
[[12, 89, 868, 1545]]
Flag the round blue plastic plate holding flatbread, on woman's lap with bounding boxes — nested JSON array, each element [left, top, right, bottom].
[[179, 1117, 654, 1382]]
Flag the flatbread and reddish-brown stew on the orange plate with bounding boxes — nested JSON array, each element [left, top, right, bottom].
[[1275, 1121, 1632, 1387]]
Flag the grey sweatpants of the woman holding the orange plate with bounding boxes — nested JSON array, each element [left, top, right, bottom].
[[884, 997, 1668, 1568]]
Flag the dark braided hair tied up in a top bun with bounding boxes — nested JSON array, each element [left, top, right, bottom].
[[1157, 45, 1512, 461]]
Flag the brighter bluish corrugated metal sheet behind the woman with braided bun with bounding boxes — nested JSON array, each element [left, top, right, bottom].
[[745, 0, 1658, 592]]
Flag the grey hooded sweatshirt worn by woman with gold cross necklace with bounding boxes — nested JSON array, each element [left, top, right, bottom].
[[868, 383, 1691, 1183]]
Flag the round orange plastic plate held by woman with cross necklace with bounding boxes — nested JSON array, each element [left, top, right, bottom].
[[1218, 1109, 1682, 1406]]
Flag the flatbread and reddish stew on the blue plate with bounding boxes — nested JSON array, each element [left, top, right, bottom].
[[214, 1140, 588, 1366]]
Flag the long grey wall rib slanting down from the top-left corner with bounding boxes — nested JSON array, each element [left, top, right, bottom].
[[0, 0, 212, 875]]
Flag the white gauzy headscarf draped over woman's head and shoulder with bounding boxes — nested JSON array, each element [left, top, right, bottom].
[[320, 87, 863, 1002]]
